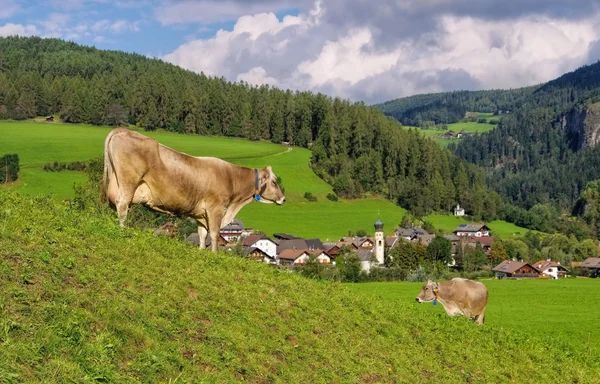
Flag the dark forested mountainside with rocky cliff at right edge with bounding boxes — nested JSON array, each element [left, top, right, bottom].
[[450, 63, 600, 211]]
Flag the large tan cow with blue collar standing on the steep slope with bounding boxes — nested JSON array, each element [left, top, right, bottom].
[[102, 128, 285, 252]]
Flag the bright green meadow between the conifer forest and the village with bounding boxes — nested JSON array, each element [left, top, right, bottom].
[[0, 122, 526, 241]]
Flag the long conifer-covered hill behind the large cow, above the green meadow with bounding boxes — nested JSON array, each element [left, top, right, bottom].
[[0, 37, 510, 224]]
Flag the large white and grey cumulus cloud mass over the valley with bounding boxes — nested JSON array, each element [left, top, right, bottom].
[[162, 0, 600, 102]]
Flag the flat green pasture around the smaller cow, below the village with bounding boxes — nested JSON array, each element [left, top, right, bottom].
[[344, 278, 600, 359]]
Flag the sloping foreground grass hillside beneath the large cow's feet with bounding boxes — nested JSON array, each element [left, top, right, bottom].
[[0, 191, 600, 383]]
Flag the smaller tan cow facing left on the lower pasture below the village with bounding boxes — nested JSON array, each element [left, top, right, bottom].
[[416, 277, 488, 324]]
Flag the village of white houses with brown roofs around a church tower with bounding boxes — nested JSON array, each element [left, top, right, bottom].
[[155, 214, 600, 279]]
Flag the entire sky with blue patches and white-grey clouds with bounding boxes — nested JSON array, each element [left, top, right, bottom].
[[0, 0, 600, 103]]
